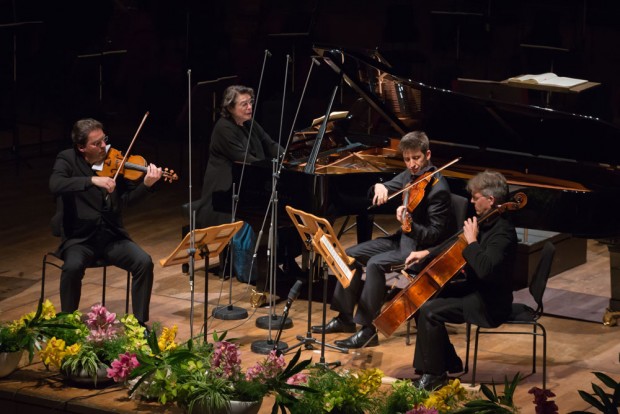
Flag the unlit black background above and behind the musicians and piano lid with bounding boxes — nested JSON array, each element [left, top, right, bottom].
[[0, 0, 620, 181]]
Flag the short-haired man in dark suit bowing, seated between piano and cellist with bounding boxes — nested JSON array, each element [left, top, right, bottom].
[[312, 131, 454, 348]]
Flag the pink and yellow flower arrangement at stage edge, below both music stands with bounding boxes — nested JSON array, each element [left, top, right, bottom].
[[108, 327, 312, 413]]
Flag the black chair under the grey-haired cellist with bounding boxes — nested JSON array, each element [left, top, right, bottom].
[[467, 242, 555, 389]]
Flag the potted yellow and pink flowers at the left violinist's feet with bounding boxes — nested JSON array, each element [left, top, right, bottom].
[[40, 304, 146, 387]]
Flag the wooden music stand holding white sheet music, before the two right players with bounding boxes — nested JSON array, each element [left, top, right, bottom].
[[286, 206, 355, 365]]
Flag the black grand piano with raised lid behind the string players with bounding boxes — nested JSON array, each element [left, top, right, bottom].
[[218, 47, 620, 310]]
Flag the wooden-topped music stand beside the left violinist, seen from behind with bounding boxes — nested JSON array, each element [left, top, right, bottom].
[[159, 221, 243, 342]]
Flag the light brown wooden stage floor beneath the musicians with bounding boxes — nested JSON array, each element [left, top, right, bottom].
[[0, 145, 620, 413]]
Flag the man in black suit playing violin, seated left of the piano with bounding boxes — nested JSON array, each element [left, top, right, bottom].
[[49, 118, 162, 326]]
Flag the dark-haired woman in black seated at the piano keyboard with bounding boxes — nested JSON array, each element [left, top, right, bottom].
[[196, 85, 284, 291]]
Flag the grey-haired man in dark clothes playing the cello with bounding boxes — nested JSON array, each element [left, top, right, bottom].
[[405, 171, 517, 390]]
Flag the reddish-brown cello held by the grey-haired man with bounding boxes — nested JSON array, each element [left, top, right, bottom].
[[373, 192, 527, 337]]
